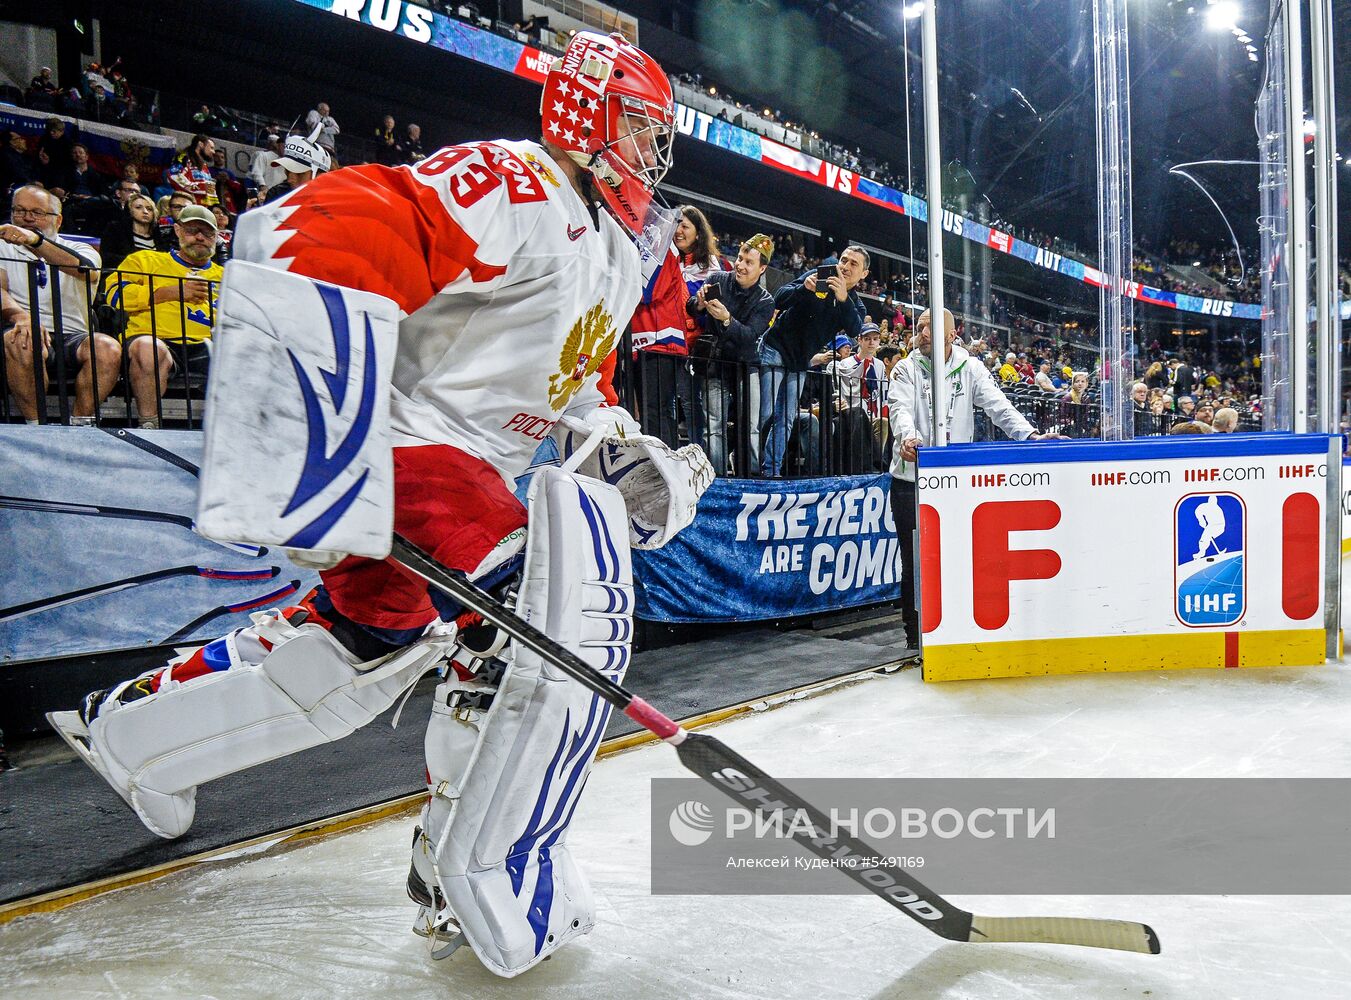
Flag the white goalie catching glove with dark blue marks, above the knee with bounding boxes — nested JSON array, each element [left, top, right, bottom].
[[555, 407, 713, 549]]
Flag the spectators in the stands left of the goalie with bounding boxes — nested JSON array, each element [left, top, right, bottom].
[[0, 56, 456, 427]]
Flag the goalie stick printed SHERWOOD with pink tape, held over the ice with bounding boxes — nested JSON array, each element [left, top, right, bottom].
[[392, 534, 1159, 955]]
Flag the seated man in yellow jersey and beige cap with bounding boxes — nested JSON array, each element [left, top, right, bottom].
[[107, 205, 223, 428]]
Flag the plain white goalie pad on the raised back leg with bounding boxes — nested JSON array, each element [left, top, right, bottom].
[[49, 611, 454, 839]]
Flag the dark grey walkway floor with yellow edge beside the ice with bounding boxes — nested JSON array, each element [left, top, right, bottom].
[[0, 616, 915, 923]]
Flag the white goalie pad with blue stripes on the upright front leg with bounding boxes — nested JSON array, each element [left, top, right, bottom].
[[415, 469, 634, 976]]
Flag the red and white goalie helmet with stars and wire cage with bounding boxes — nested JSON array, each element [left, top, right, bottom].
[[539, 31, 676, 236]]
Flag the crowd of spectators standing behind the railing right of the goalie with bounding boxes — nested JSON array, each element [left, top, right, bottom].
[[635, 207, 1280, 477]]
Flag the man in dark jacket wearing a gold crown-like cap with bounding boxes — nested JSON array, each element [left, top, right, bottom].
[[685, 232, 774, 476]]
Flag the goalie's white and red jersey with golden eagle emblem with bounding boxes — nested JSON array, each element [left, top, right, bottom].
[[235, 141, 640, 482]]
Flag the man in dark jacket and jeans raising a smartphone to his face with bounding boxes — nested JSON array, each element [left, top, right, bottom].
[[759, 246, 870, 478]]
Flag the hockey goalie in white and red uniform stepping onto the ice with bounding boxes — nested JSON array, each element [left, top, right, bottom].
[[50, 32, 712, 976]]
